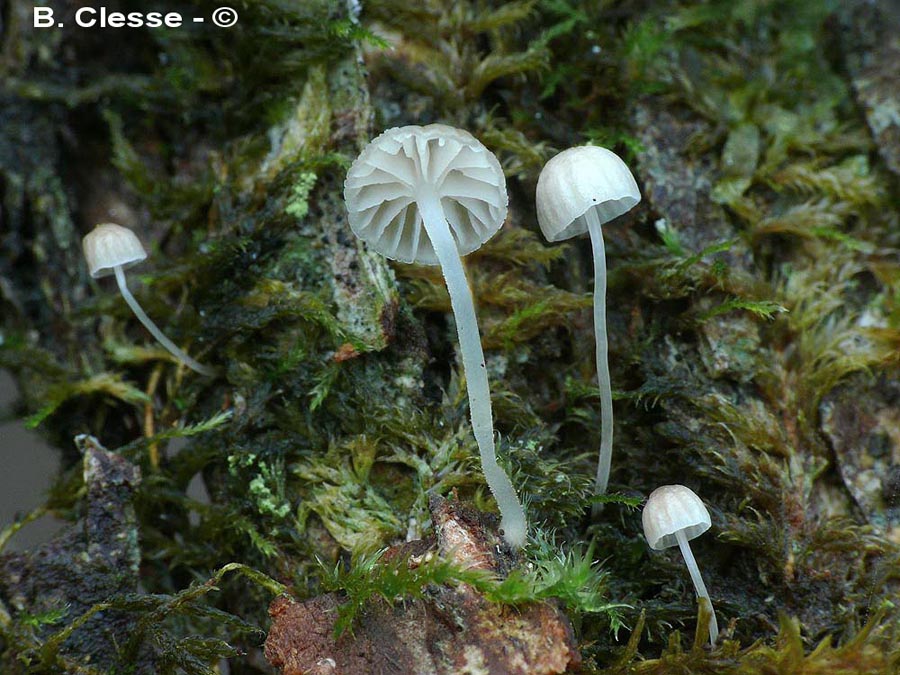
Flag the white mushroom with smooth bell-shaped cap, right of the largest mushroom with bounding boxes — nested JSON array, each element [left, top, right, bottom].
[[536, 145, 641, 502]]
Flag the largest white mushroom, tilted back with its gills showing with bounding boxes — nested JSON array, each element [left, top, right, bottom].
[[344, 124, 527, 547]]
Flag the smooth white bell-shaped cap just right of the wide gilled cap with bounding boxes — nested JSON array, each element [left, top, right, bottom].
[[537, 145, 641, 241]]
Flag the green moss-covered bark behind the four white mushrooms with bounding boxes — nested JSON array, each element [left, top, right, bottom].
[[0, 0, 900, 673]]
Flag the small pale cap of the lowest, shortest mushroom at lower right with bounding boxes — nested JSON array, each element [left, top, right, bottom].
[[641, 485, 711, 551]]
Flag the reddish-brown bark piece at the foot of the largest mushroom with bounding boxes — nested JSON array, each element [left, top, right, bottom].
[[265, 499, 580, 675]]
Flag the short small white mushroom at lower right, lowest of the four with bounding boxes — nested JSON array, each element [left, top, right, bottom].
[[641, 485, 719, 645]]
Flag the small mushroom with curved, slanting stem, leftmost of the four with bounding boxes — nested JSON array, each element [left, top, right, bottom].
[[81, 223, 216, 375]]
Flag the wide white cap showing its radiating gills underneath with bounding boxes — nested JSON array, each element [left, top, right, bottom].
[[344, 124, 508, 265]]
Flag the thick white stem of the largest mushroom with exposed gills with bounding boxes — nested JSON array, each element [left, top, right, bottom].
[[416, 191, 527, 548]]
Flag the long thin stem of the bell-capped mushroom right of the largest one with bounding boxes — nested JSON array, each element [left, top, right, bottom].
[[584, 208, 613, 502]]
